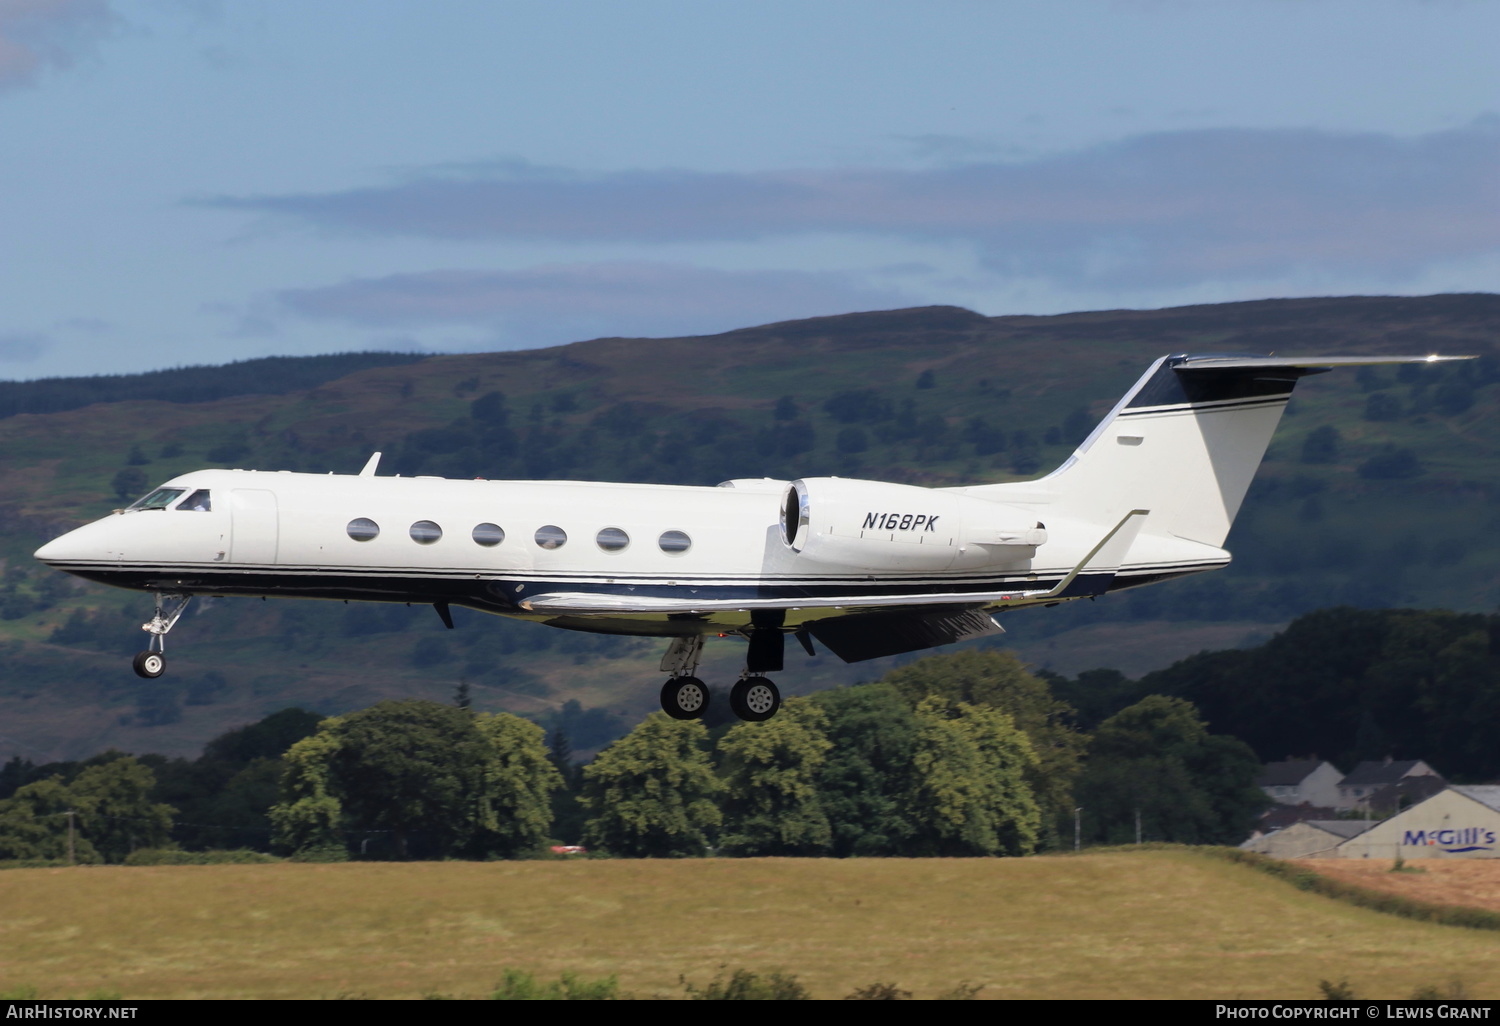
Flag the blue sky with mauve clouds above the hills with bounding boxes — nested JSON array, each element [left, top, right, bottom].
[[0, 0, 1500, 380]]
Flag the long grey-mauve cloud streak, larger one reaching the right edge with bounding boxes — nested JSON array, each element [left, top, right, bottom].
[[210, 117, 1500, 288]]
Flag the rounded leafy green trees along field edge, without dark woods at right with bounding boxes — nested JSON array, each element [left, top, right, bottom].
[[0, 651, 1265, 861]]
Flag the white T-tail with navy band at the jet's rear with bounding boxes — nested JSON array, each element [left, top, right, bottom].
[[965, 354, 1472, 549]]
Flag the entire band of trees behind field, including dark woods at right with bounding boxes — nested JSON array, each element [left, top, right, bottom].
[[0, 609, 1500, 860]]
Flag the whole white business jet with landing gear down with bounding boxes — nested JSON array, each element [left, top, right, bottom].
[[36, 356, 1469, 720]]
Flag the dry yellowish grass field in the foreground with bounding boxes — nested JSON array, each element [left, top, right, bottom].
[[0, 851, 1500, 999]]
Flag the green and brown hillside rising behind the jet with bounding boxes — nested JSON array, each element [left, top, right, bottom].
[[0, 294, 1500, 761]]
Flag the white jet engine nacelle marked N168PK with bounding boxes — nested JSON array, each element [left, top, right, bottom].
[[782, 477, 1047, 570]]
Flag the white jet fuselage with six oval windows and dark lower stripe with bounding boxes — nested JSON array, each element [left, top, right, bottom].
[[38, 470, 1229, 636]]
